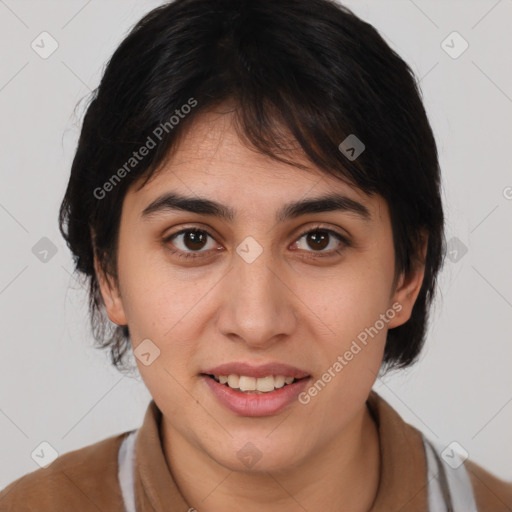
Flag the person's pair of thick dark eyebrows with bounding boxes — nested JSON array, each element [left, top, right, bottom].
[[141, 192, 372, 222]]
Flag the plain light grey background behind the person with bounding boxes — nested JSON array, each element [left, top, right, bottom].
[[0, 0, 512, 488]]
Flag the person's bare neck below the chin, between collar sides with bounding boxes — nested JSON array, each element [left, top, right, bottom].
[[162, 405, 380, 512]]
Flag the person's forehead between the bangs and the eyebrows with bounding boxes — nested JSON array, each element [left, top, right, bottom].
[[127, 112, 385, 224]]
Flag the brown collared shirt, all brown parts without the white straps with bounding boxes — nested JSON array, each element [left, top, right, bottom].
[[0, 391, 512, 512]]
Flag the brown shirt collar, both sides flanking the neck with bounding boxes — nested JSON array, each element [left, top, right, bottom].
[[134, 391, 428, 512]]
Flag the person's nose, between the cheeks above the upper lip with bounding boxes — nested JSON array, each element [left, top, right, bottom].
[[217, 243, 299, 348]]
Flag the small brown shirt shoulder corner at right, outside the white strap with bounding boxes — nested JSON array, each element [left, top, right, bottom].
[[464, 460, 512, 512]]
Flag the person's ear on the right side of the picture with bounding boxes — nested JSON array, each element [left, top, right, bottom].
[[388, 232, 428, 329]]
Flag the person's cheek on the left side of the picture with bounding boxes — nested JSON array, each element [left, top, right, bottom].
[[118, 244, 227, 388]]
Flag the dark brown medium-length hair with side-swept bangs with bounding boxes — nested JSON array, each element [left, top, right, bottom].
[[59, 0, 445, 369]]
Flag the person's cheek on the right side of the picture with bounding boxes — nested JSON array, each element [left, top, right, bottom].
[[288, 247, 394, 394]]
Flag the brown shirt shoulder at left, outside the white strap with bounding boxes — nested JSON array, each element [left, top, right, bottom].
[[0, 432, 129, 512]]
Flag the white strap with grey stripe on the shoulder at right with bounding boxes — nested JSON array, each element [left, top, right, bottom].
[[423, 436, 478, 512]]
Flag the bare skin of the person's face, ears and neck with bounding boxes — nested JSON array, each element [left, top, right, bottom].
[[96, 109, 424, 512]]
